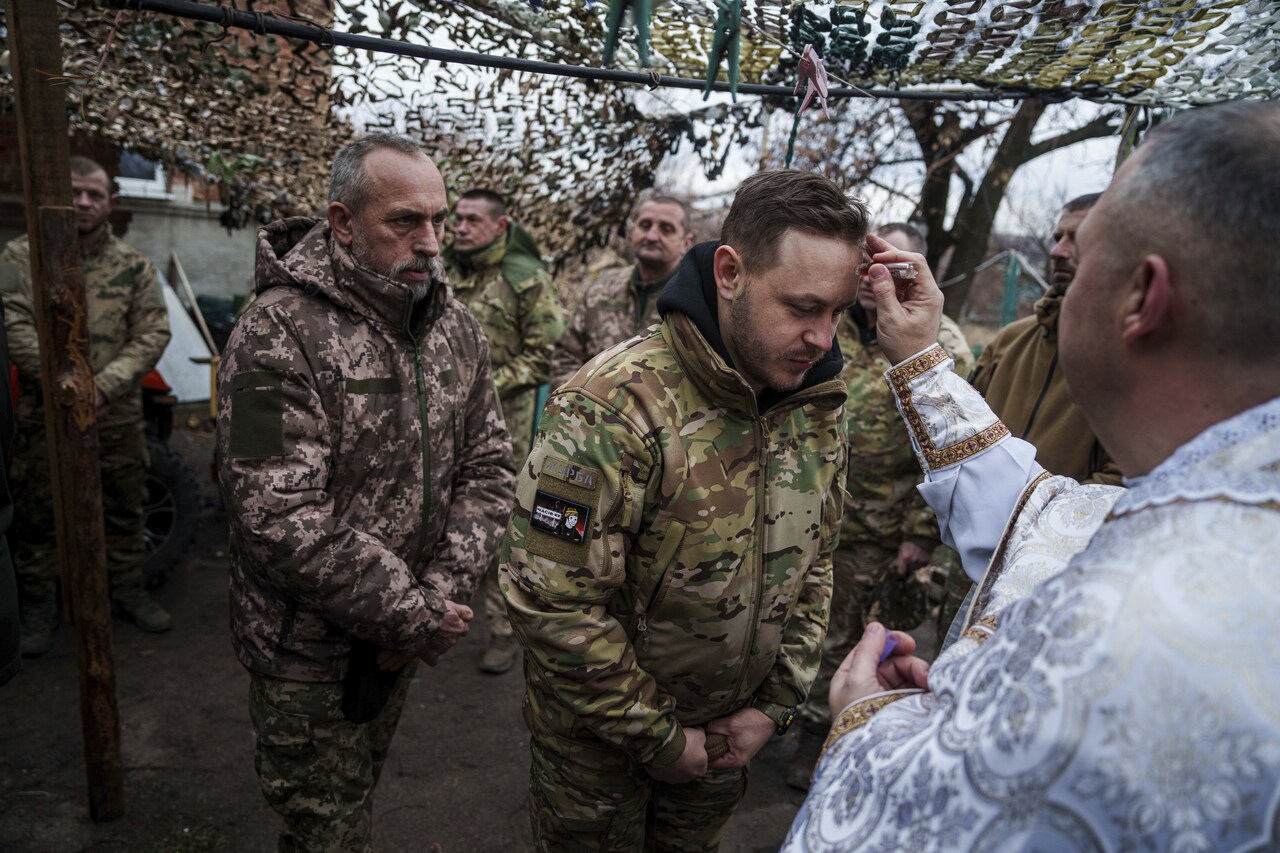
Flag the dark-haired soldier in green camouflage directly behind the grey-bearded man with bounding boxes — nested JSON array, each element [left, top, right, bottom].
[[444, 188, 564, 674]]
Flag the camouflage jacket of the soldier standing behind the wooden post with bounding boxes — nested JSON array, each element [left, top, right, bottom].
[[0, 225, 169, 428]]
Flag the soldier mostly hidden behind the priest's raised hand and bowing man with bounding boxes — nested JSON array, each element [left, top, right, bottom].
[[786, 223, 973, 790]]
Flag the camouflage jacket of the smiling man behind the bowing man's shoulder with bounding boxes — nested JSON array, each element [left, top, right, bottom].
[[552, 266, 671, 387]]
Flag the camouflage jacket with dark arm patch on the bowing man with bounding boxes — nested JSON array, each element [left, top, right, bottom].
[[500, 243, 845, 766]]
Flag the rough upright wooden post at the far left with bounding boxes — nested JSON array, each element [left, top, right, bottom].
[[5, 0, 124, 821]]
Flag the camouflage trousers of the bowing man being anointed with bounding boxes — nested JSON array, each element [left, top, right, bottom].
[[526, 704, 746, 853]]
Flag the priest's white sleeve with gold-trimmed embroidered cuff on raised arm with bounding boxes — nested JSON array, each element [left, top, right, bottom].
[[884, 346, 1044, 581]]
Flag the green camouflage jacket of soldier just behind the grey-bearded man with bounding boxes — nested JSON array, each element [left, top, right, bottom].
[[445, 222, 564, 461]]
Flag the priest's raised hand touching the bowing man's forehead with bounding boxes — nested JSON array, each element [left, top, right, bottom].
[[864, 234, 942, 364]]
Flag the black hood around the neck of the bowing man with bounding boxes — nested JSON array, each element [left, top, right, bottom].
[[658, 241, 845, 411]]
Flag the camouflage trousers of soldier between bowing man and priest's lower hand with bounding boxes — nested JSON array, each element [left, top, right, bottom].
[[797, 542, 897, 734]]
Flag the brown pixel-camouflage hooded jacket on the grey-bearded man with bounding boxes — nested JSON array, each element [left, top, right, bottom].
[[218, 218, 515, 681]]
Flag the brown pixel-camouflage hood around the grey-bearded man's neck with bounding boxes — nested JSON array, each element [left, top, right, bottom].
[[255, 216, 451, 330]]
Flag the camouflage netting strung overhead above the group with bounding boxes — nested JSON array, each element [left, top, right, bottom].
[[0, 0, 1280, 257]]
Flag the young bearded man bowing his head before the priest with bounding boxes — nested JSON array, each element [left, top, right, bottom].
[[500, 170, 867, 853]]
